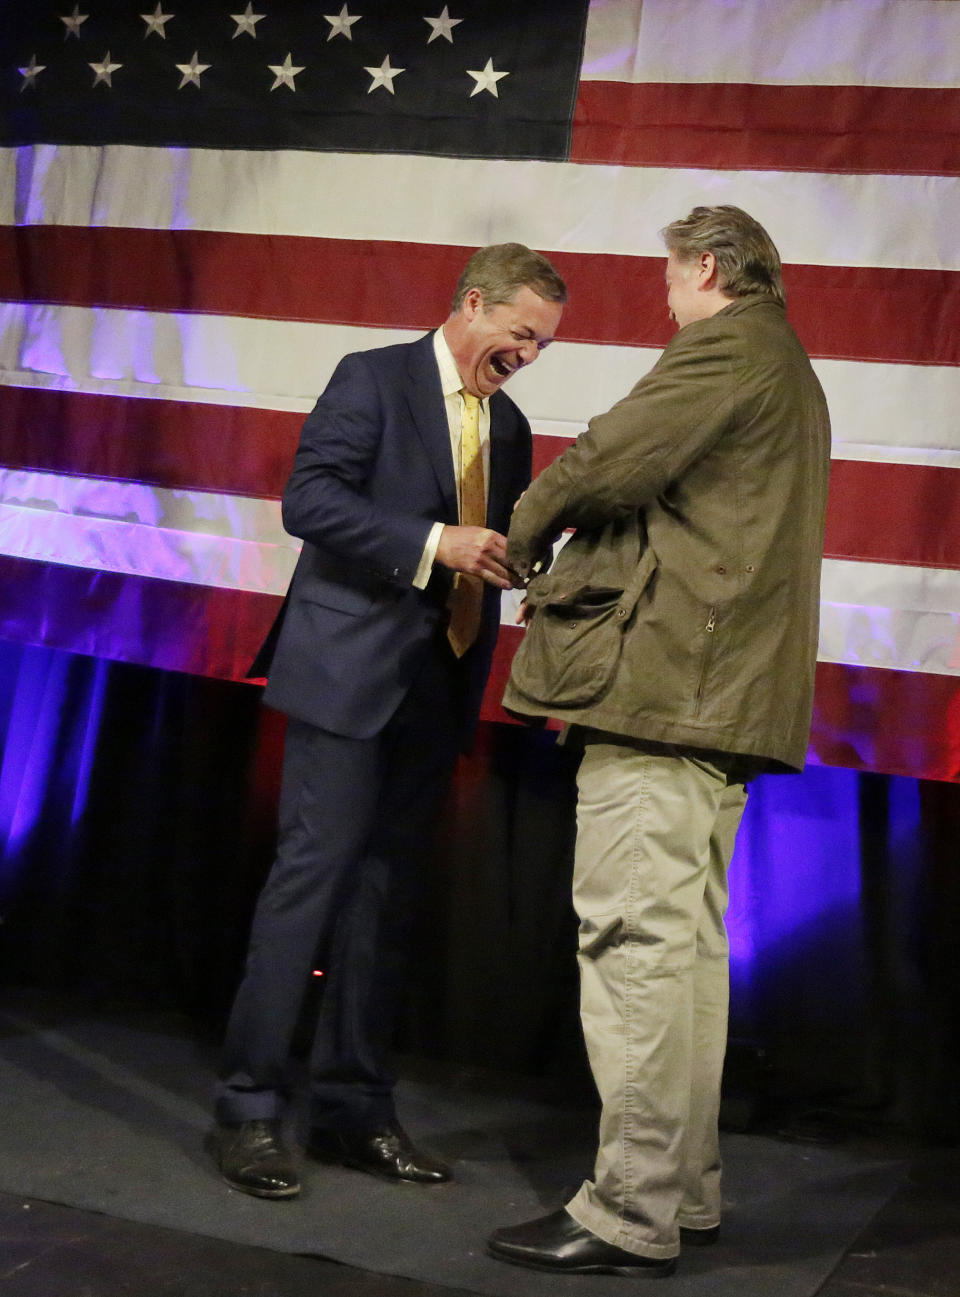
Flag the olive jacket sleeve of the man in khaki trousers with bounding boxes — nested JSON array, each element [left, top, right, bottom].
[[507, 320, 737, 576]]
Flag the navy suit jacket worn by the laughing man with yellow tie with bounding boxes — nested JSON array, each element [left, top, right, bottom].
[[250, 333, 531, 741]]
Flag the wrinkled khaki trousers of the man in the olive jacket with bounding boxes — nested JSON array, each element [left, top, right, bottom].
[[567, 747, 746, 1258]]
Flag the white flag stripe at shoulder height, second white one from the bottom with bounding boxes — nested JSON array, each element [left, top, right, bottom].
[[0, 302, 960, 463]]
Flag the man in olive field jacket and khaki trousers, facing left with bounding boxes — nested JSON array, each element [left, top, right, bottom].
[[489, 206, 829, 1275]]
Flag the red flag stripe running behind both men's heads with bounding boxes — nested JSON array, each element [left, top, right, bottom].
[[0, 226, 960, 364]]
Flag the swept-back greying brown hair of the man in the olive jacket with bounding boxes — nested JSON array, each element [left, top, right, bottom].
[[660, 205, 785, 306]]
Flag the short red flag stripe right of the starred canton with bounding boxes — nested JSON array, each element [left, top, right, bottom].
[[571, 80, 960, 175]]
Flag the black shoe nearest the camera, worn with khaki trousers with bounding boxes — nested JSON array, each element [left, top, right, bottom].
[[486, 1208, 677, 1279]]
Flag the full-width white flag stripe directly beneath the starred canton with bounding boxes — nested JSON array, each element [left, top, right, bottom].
[[0, 143, 960, 274]]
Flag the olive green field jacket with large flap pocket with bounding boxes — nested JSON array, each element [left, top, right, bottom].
[[503, 296, 830, 769]]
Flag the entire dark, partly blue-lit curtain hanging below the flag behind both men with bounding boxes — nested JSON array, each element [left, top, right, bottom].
[[0, 642, 960, 1140]]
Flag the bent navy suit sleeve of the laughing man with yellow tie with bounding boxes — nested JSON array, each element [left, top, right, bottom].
[[283, 353, 431, 584]]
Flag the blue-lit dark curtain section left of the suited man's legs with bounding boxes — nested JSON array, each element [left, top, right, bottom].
[[0, 642, 283, 1016]]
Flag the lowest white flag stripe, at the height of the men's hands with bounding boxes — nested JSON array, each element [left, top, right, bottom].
[[0, 470, 960, 674]]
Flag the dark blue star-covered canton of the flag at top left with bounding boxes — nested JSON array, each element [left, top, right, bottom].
[[0, 0, 588, 158]]
